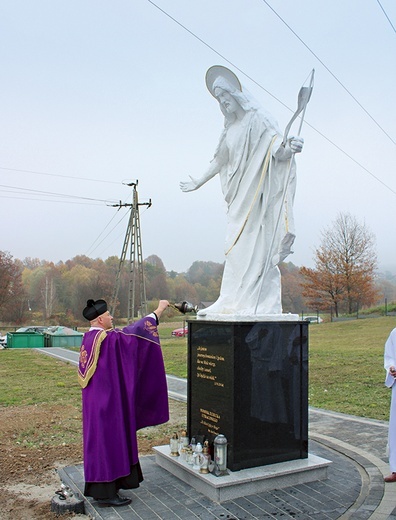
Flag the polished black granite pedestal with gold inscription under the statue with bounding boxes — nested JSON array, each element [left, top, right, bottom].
[[187, 320, 308, 471]]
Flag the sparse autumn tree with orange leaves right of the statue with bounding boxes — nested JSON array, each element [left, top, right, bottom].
[[300, 213, 378, 316]]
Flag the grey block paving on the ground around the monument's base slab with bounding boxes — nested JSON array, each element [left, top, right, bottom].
[[60, 442, 372, 520]]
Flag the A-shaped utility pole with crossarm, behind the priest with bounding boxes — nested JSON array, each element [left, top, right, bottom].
[[111, 181, 151, 323]]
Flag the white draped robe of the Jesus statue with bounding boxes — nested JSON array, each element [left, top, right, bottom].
[[203, 110, 296, 316]]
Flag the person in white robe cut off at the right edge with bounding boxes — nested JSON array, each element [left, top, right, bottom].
[[384, 328, 396, 482]]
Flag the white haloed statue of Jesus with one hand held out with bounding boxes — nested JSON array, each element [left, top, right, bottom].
[[180, 66, 303, 320]]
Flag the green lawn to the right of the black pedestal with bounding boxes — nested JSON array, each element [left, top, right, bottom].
[[309, 317, 396, 420]]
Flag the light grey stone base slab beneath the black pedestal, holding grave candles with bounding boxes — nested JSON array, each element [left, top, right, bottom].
[[154, 445, 331, 504]]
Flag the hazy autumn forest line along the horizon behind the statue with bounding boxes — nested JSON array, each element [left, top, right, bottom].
[[0, 252, 396, 326]]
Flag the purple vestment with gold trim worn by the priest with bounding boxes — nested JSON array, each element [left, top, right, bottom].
[[78, 317, 169, 482]]
